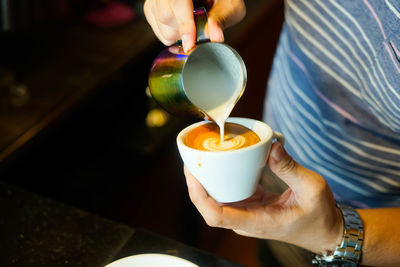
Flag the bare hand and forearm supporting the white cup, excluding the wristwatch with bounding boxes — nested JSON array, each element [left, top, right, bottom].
[[185, 143, 400, 266]]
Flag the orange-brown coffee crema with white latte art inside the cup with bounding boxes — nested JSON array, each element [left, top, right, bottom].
[[185, 122, 261, 151]]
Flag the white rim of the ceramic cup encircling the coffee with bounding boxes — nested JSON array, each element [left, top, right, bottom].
[[176, 117, 273, 154]]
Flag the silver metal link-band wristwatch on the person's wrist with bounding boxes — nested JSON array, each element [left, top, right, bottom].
[[312, 204, 364, 267]]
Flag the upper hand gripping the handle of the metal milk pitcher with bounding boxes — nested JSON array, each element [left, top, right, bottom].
[[144, 0, 246, 51]]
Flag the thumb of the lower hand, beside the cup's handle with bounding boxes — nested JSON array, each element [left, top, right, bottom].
[[268, 142, 302, 192]]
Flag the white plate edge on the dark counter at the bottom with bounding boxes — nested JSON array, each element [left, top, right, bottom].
[[105, 253, 199, 267]]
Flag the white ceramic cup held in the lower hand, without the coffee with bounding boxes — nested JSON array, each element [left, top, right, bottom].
[[177, 118, 285, 203]]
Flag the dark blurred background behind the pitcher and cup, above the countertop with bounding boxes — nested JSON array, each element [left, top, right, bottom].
[[0, 0, 283, 266]]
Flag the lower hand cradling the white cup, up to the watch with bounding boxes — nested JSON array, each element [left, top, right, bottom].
[[185, 142, 343, 254]]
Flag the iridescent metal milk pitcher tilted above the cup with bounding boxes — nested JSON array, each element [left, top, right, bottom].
[[149, 8, 247, 120]]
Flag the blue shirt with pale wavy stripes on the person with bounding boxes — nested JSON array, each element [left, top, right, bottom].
[[264, 0, 400, 208]]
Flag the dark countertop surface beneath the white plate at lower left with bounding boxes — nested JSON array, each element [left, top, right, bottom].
[[0, 182, 244, 267]]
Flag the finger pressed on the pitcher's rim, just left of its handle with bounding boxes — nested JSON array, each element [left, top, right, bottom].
[[170, 0, 196, 52]]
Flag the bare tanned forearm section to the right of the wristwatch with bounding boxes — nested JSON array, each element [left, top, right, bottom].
[[357, 208, 400, 266]]
